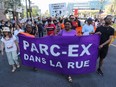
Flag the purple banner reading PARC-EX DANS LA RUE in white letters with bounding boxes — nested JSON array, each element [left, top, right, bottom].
[[19, 35, 100, 75]]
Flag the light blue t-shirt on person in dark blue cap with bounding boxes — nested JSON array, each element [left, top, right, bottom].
[[82, 24, 94, 35]]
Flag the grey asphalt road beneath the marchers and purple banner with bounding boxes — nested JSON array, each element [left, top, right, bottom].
[[0, 40, 116, 87]]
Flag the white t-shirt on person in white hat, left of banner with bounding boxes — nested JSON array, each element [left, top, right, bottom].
[[1, 36, 17, 52]]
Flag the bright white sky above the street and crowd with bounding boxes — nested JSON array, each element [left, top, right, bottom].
[[31, 0, 89, 13]]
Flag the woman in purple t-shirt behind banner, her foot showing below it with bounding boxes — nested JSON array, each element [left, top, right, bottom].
[[58, 21, 77, 82]]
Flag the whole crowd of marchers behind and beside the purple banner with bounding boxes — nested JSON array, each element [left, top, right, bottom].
[[0, 15, 114, 82]]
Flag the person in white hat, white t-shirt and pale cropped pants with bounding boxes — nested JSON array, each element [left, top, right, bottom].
[[1, 27, 20, 72]]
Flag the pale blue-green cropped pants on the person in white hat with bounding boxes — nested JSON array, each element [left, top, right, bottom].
[[6, 51, 18, 65]]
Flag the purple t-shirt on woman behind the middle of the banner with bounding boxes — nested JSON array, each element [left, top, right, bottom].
[[58, 29, 76, 36]]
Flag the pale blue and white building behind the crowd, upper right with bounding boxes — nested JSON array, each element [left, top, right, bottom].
[[67, 0, 109, 15]]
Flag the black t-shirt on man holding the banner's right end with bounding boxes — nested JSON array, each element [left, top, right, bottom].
[[96, 26, 114, 47]]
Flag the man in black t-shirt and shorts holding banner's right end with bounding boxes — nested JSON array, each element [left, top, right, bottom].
[[96, 15, 114, 76]]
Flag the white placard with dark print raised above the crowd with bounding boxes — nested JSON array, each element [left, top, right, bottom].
[[49, 3, 66, 17]]
